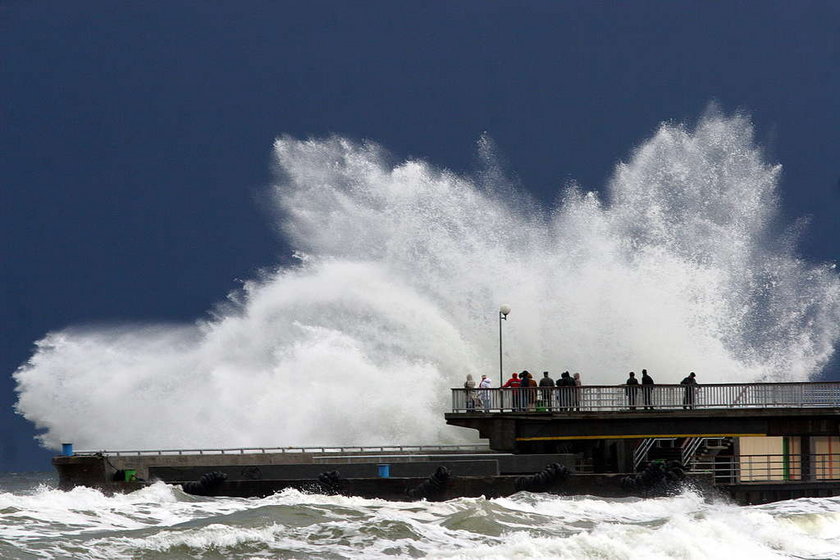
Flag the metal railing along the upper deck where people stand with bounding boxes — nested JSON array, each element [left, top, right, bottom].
[[452, 382, 840, 412]]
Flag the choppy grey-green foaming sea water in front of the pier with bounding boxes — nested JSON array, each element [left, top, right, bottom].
[[0, 473, 840, 560]]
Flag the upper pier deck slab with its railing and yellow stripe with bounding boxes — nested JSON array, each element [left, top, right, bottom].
[[445, 383, 840, 452]]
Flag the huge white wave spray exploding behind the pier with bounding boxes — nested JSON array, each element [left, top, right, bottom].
[[14, 112, 840, 449]]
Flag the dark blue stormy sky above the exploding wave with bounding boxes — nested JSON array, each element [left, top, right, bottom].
[[0, 0, 840, 471]]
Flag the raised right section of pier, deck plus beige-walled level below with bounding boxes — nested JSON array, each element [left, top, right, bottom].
[[445, 382, 840, 503]]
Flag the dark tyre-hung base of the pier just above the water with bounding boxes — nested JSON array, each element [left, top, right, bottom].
[[53, 455, 840, 505]]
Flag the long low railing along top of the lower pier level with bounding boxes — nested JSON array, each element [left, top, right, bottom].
[[73, 444, 490, 457]]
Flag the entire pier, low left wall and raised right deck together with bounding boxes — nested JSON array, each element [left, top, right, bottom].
[[53, 383, 840, 504]]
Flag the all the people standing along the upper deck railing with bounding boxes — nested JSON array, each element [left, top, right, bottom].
[[464, 369, 697, 411]]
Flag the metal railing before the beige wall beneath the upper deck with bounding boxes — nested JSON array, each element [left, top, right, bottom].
[[691, 453, 840, 484]]
